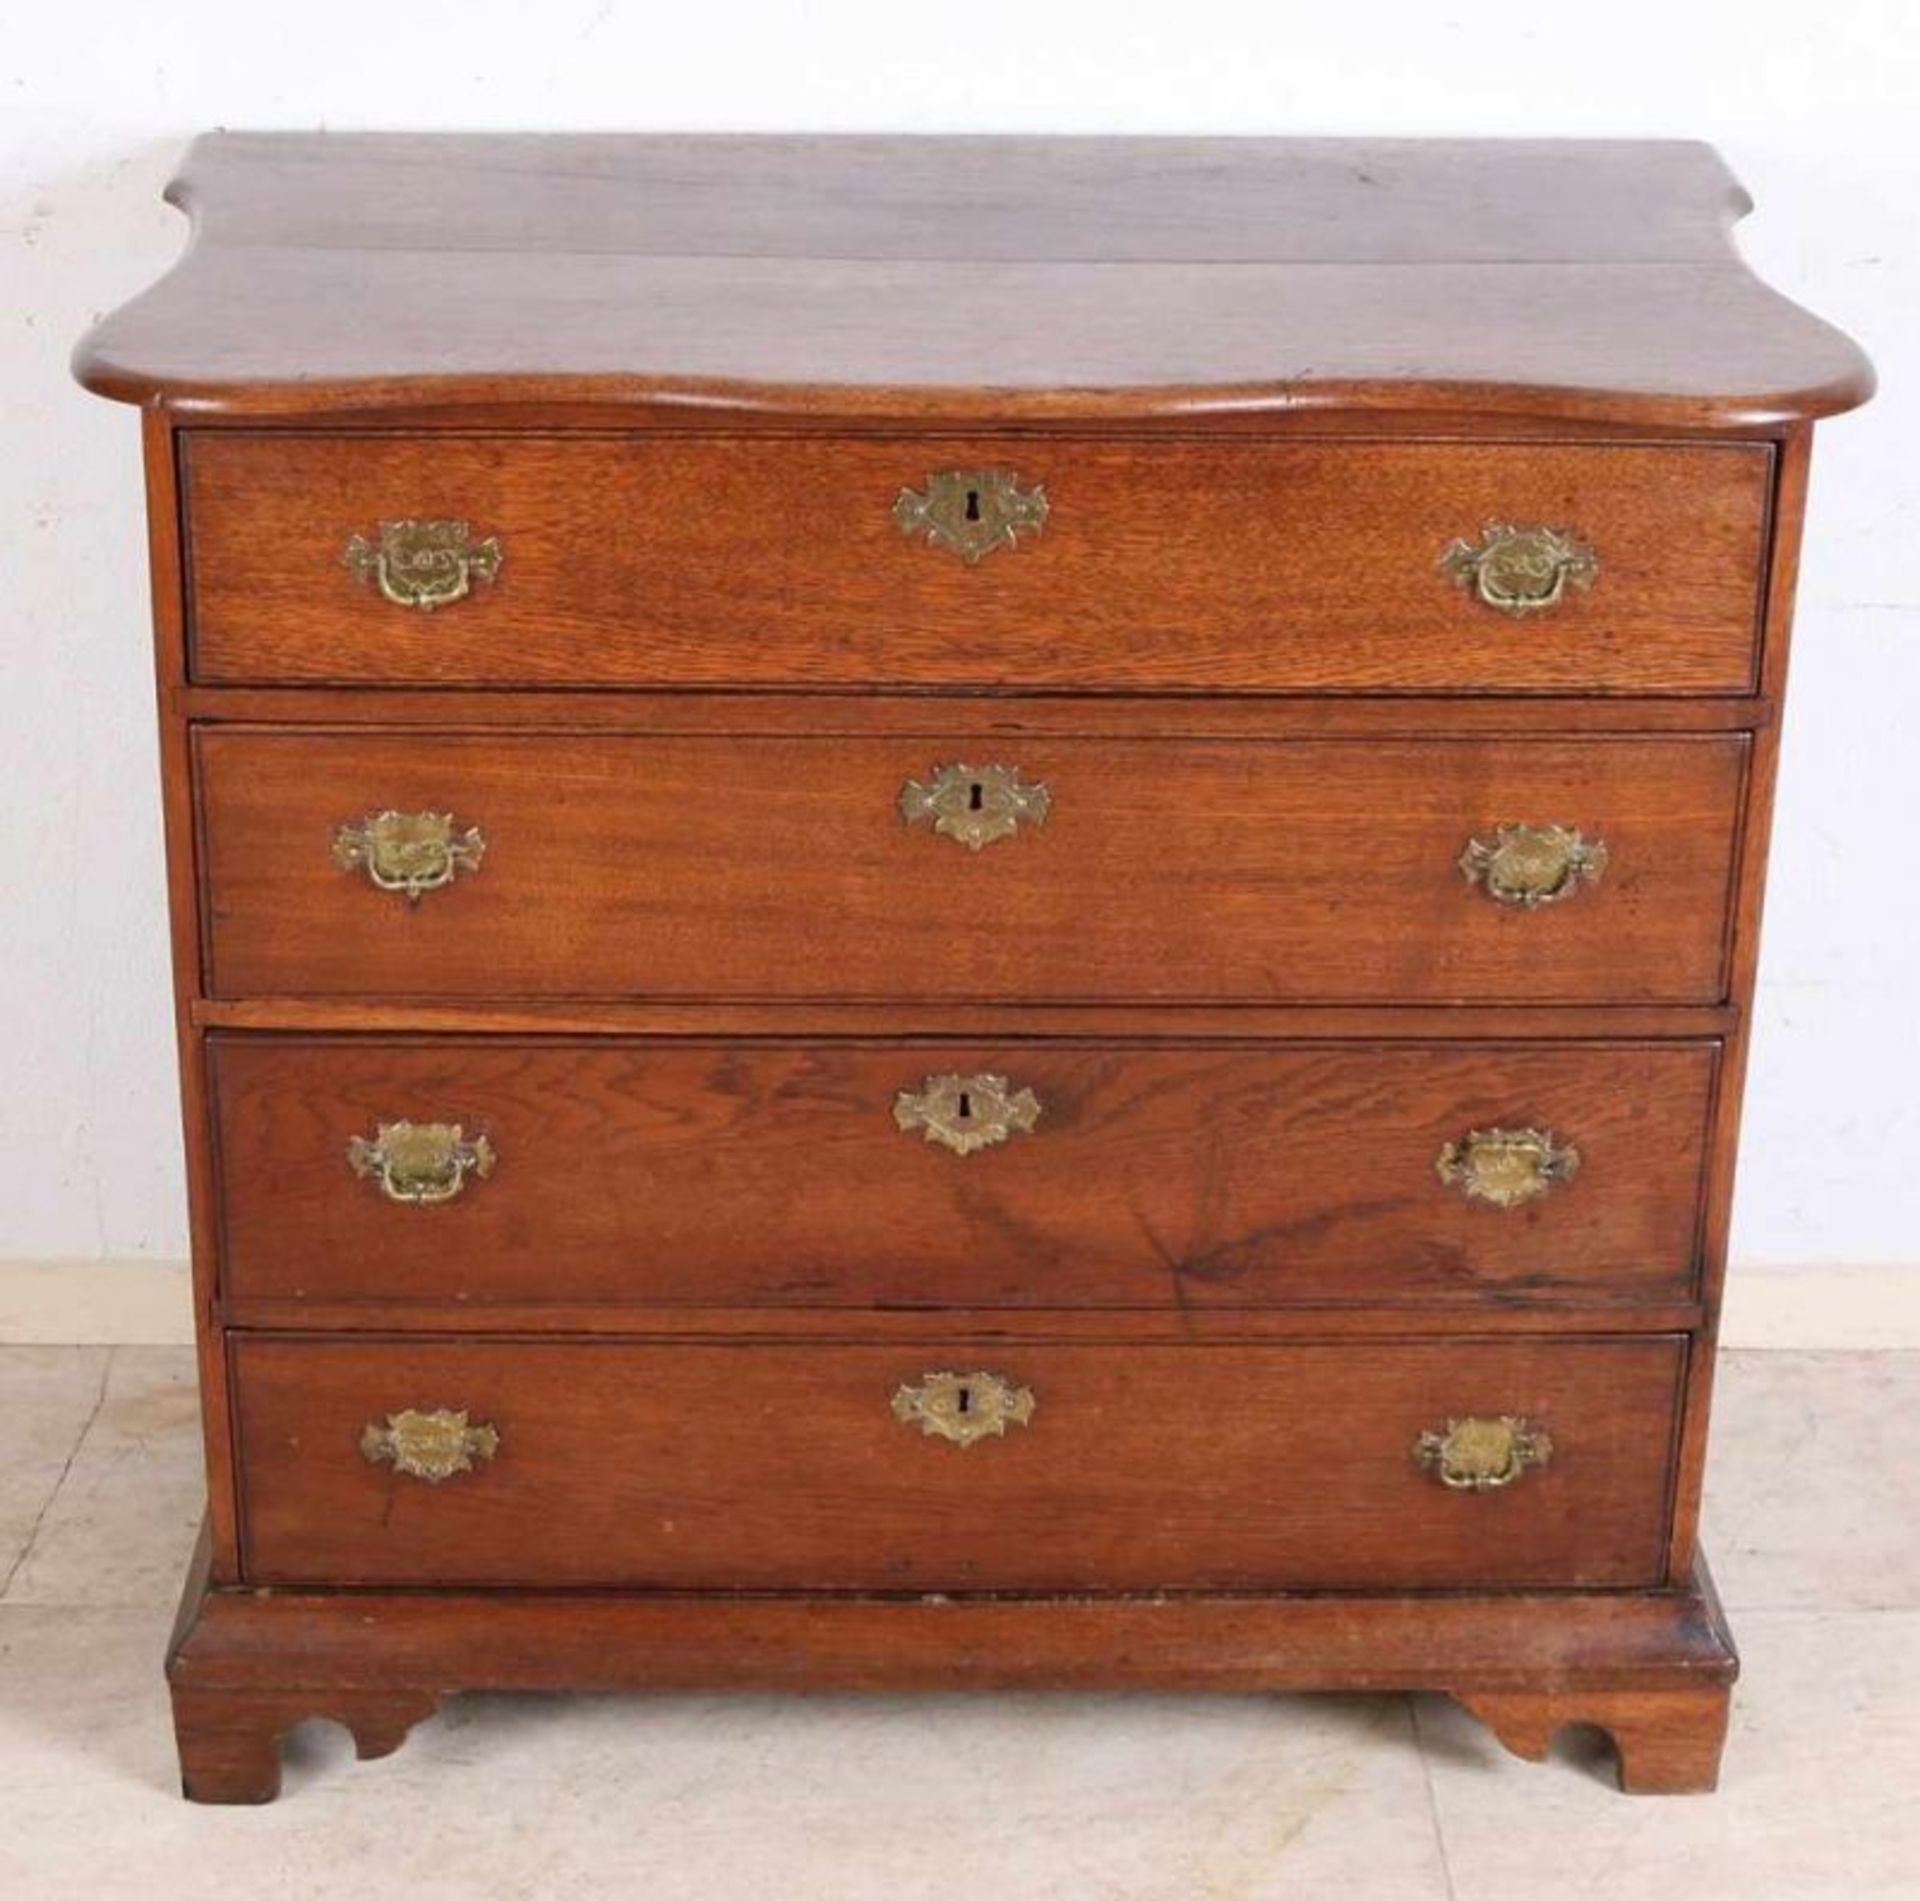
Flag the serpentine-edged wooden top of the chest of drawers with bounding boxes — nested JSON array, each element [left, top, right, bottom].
[[75, 132, 1872, 428]]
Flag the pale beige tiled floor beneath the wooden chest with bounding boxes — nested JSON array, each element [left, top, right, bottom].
[[0, 1348, 1920, 1901]]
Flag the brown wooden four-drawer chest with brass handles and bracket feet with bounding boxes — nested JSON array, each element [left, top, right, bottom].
[[79, 136, 1870, 1799]]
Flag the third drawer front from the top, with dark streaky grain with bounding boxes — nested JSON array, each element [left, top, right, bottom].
[[211, 1037, 1716, 1308]]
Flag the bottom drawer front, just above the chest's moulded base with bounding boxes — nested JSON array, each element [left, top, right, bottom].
[[232, 1336, 1684, 1592]]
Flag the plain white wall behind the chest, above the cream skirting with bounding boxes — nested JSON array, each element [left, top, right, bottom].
[[0, 0, 1920, 1269]]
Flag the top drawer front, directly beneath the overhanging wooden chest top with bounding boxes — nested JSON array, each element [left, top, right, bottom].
[[186, 430, 1772, 693]]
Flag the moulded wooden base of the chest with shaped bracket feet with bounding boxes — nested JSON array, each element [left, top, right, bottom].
[[167, 1555, 1740, 1801]]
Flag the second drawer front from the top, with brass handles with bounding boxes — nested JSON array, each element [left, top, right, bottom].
[[198, 728, 1747, 1002]]
